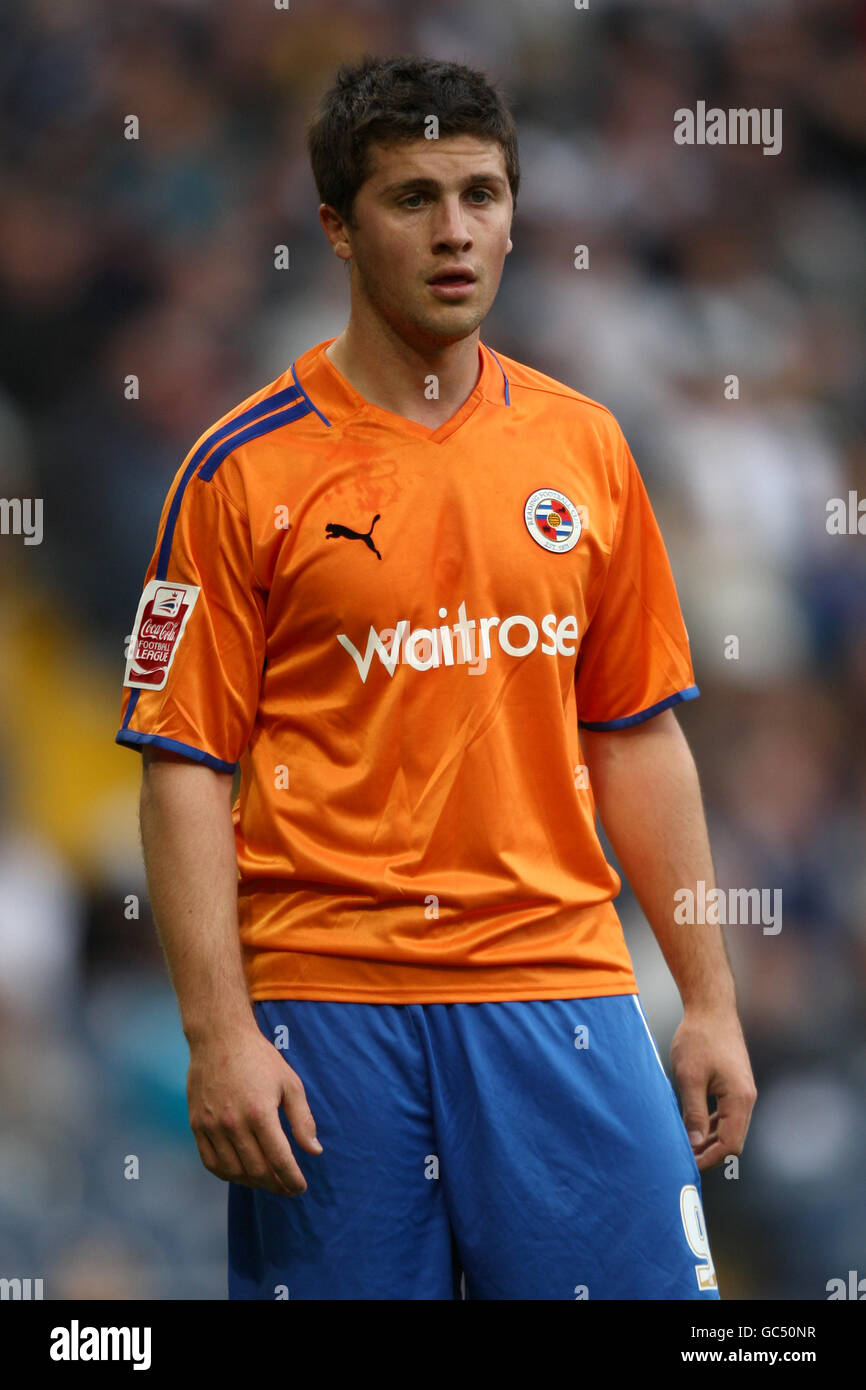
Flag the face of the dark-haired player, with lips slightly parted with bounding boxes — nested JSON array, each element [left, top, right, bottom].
[[320, 135, 513, 346]]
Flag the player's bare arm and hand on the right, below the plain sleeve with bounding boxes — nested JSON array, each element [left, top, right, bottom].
[[580, 709, 756, 1169]]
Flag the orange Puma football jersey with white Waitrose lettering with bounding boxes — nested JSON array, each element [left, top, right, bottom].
[[117, 339, 699, 1004]]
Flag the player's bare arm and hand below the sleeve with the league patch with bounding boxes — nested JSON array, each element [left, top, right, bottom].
[[140, 746, 321, 1195]]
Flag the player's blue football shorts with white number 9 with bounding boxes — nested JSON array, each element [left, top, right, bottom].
[[228, 994, 719, 1300]]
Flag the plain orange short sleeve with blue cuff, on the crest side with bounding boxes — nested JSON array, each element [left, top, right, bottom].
[[574, 436, 701, 730]]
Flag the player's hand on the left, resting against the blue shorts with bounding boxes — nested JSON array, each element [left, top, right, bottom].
[[186, 1022, 322, 1197]]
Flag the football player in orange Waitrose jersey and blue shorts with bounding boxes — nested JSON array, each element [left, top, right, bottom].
[[117, 56, 755, 1300]]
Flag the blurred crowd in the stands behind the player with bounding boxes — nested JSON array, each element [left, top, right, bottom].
[[0, 0, 866, 1300]]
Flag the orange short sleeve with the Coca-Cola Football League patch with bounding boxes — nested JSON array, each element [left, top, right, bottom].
[[115, 473, 265, 773]]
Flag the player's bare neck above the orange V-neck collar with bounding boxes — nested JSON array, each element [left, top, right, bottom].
[[327, 310, 480, 430]]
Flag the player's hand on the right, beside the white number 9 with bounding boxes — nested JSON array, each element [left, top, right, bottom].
[[670, 1005, 758, 1172]]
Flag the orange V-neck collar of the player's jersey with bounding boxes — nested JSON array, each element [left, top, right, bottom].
[[291, 336, 510, 443]]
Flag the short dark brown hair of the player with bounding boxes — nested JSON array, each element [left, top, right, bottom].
[[307, 53, 520, 225]]
